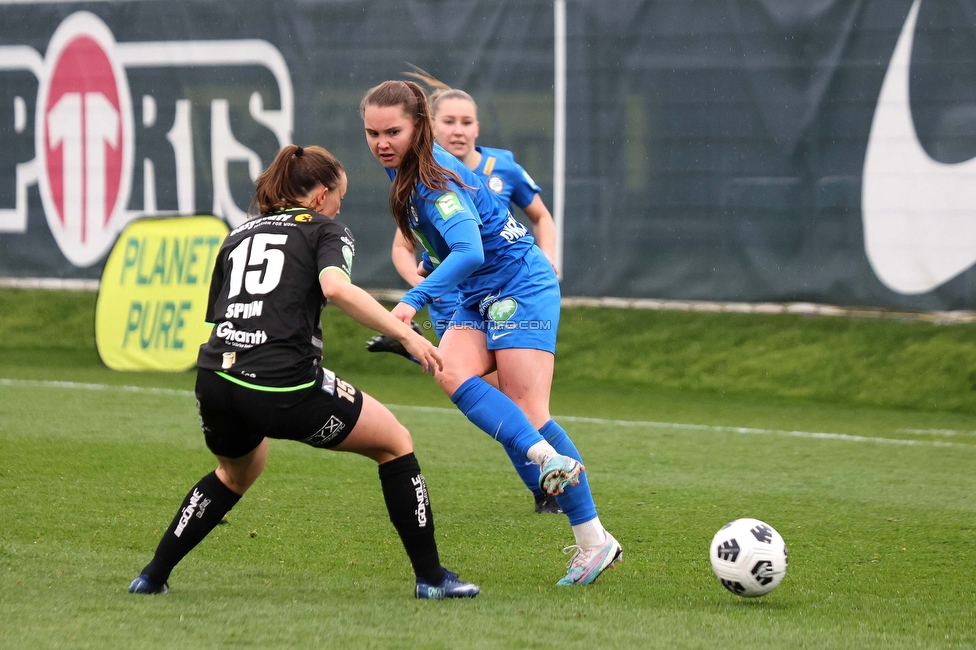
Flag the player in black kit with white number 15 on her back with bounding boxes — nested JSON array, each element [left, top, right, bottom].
[[129, 145, 479, 599]]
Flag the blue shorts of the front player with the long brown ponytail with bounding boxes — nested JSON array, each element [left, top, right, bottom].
[[449, 247, 560, 354]]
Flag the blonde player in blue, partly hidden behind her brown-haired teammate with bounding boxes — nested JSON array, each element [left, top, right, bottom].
[[367, 73, 562, 514]]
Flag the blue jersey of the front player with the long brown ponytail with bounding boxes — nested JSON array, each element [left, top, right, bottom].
[[387, 144, 535, 310]]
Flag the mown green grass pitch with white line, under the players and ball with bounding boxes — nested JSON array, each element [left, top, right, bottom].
[[0, 292, 976, 648]]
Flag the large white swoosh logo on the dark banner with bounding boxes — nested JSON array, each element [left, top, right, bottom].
[[861, 0, 976, 294]]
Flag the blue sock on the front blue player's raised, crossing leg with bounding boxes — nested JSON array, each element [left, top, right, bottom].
[[451, 377, 542, 456]]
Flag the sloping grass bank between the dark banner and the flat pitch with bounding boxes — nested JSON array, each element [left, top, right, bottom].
[[0, 289, 976, 415]]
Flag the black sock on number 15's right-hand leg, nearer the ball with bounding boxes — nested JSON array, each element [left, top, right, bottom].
[[379, 452, 444, 584]]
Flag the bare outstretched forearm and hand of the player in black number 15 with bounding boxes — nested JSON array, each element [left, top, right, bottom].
[[319, 268, 444, 374]]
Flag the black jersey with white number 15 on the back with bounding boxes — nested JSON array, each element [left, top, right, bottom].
[[197, 209, 356, 388]]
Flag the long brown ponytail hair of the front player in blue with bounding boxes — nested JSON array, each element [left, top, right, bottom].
[[359, 81, 467, 242]]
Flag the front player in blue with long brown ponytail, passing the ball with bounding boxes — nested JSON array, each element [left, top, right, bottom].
[[360, 81, 622, 585]]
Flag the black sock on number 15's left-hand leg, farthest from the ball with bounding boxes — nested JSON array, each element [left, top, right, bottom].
[[142, 472, 241, 585]]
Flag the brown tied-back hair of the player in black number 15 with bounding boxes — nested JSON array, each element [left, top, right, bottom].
[[254, 144, 344, 214]]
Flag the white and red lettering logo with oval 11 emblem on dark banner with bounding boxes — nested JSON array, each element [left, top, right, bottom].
[[0, 11, 294, 267]]
